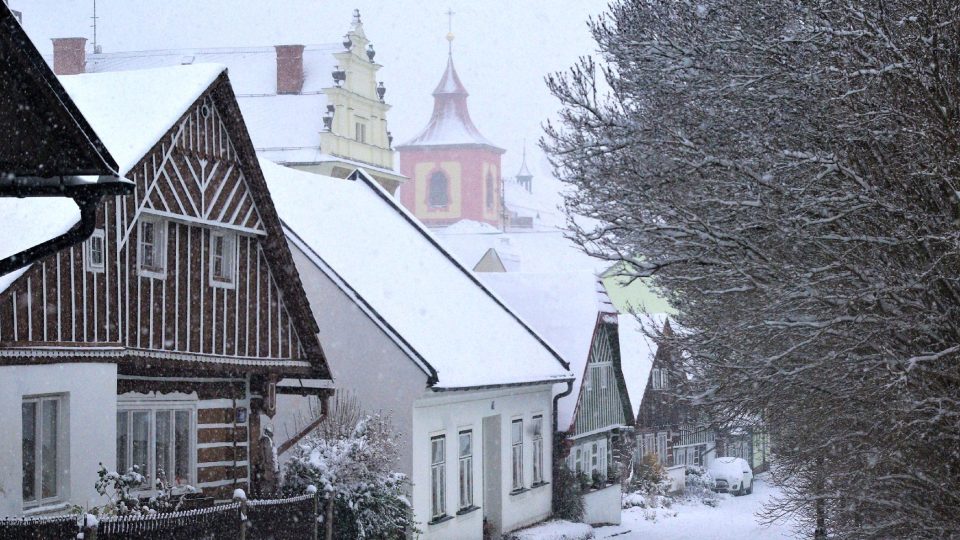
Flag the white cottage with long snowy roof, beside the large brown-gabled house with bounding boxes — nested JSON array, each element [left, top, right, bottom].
[[261, 161, 572, 539]]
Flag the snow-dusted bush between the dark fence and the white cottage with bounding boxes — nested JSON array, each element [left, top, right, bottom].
[[281, 415, 414, 538]]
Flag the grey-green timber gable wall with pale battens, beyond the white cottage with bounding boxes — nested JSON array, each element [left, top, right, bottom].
[[574, 324, 626, 435]]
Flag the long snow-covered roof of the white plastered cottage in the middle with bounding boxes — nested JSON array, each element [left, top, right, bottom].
[[261, 160, 571, 389]]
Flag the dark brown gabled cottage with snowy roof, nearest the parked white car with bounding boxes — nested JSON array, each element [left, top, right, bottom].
[[619, 314, 721, 490]]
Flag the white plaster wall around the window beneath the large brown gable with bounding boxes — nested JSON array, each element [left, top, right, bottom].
[[0, 363, 117, 516]]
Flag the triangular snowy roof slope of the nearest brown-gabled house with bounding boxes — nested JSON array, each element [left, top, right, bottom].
[[60, 64, 225, 175]]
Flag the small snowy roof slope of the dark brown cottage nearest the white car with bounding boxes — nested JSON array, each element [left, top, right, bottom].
[[618, 313, 666, 414]]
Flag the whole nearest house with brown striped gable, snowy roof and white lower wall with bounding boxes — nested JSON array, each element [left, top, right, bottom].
[[0, 65, 330, 515]]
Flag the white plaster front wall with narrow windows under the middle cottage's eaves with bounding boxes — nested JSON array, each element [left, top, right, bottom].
[[413, 385, 553, 539]]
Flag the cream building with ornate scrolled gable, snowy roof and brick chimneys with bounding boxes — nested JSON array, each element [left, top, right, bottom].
[[52, 10, 405, 192]]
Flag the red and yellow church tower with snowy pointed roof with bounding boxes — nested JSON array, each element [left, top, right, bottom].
[[397, 27, 504, 228]]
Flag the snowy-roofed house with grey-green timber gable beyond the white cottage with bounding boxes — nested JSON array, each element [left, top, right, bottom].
[[478, 272, 633, 524]]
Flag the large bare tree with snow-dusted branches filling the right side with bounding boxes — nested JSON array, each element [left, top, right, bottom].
[[543, 0, 960, 538]]
